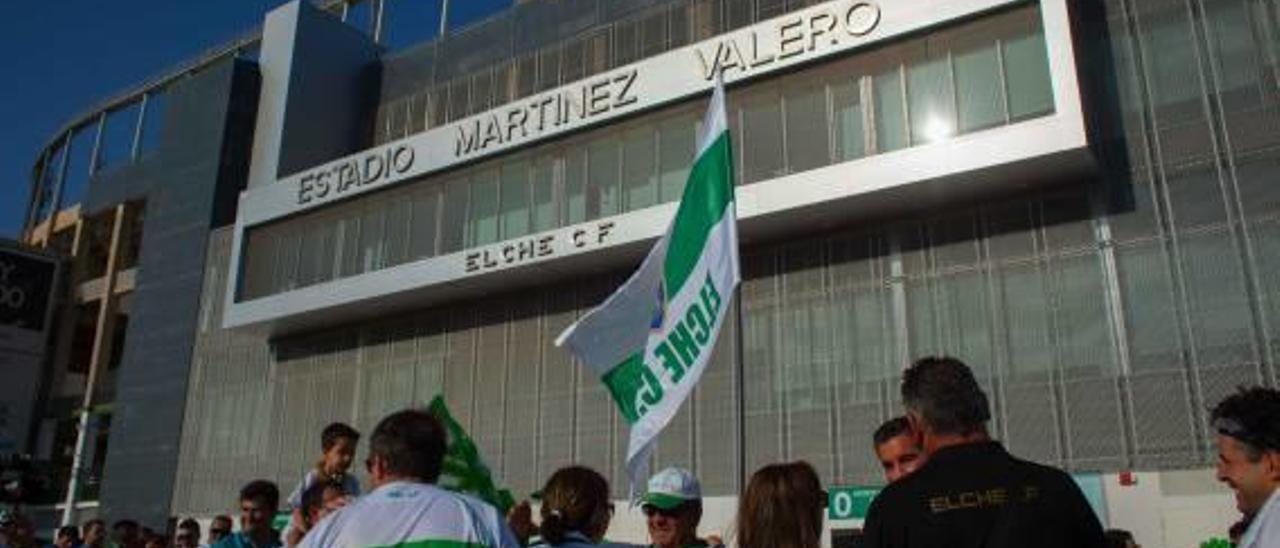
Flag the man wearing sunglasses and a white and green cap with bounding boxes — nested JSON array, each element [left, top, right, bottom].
[[641, 467, 719, 548]]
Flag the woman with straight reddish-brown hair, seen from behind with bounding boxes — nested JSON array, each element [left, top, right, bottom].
[[736, 461, 827, 548]]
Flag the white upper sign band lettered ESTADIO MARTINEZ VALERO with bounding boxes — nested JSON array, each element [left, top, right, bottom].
[[239, 0, 1016, 227]]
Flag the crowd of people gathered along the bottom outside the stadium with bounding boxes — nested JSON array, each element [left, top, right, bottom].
[[0, 357, 1280, 548]]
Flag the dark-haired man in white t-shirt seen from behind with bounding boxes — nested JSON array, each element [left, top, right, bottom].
[[298, 410, 520, 548]]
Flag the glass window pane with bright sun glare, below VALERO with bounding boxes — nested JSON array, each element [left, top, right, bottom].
[[906, 54, 956, 143]]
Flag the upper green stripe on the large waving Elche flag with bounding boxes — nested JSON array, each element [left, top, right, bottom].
[[663, 132, 733, 301]]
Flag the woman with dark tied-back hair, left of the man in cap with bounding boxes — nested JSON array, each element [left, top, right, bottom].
[[534, 466, 613, 548]]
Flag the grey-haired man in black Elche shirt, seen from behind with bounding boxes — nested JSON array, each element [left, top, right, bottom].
[[864, 357, 1106, 548]]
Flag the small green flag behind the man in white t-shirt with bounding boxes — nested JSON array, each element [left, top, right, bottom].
[[426, 396, 516, 515]]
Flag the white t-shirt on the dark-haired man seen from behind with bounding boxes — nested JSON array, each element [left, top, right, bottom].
[[298, 481, 520, 548]]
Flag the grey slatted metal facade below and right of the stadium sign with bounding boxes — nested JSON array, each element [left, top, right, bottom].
[[173, 0, 1280, 545]]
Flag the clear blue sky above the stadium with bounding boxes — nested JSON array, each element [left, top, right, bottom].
[[0, 0, 511, 238]]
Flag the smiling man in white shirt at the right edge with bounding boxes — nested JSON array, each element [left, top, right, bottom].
[[1212, 388, 1280, 548]]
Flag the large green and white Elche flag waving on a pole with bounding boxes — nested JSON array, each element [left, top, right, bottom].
[[556, 76, 741, 499]]
